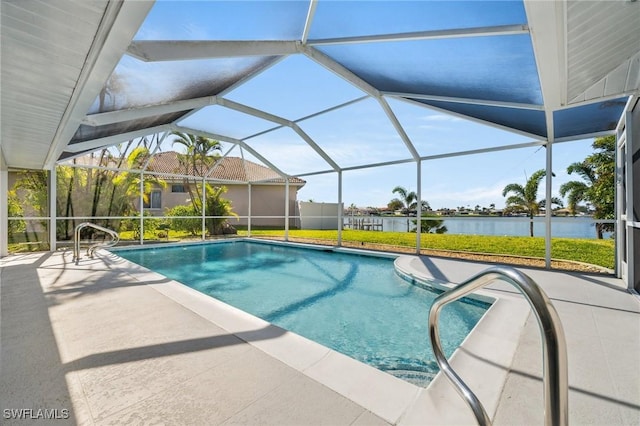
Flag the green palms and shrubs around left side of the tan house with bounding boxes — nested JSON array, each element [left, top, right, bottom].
[[8, 132, 234, 242]]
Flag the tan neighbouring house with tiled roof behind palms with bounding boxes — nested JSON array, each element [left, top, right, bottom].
[[135, 151, 306, 226]]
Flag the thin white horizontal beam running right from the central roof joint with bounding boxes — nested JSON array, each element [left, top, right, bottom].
[[307, 25, 529, 46]]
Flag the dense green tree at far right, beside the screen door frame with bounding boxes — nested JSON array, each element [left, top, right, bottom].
[[560, 136, 616, 239]]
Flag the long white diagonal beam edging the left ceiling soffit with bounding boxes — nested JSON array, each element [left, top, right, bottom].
[[44, 1, 154, 169]]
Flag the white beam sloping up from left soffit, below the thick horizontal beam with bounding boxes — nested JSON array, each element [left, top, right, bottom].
[[82, 96, 216, 127]]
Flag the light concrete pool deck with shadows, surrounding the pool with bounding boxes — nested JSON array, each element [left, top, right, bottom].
[[0, 245, 640, 425]]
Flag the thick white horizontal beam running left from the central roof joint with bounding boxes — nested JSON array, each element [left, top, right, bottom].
[[127, 40, 300, 62]]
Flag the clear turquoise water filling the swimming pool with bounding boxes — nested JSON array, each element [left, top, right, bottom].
[[118, 241, 489, 386]]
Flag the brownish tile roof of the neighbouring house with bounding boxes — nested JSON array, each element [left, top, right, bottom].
[[146, 151, 306, 185]]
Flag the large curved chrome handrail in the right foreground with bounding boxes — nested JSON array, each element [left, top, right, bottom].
[[429, 267, 569, 426]]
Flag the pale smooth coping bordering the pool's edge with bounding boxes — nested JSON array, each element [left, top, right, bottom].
[[100, 238, 529, 424]]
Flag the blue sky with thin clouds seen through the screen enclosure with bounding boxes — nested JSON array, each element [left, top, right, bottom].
[[94, 1, 604, 209]]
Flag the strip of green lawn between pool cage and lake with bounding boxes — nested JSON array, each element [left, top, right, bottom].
[[239, 229, 615, 269]]
